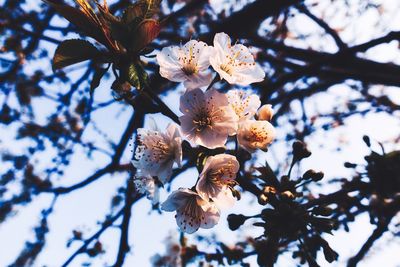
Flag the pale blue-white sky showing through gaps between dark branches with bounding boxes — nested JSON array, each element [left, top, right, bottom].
[[0, 0, 400, 267]]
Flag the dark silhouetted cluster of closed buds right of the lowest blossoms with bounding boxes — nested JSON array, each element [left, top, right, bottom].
[[228, 141, 338, 266]]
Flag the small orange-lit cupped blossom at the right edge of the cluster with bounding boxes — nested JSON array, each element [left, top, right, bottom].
[[237, 120, 276, 153]]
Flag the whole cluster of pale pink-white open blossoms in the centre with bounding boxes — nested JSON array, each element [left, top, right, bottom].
[[133, 33, 275, 233]]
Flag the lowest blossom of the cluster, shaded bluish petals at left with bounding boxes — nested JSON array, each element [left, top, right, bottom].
[[161, 188, 219, 234]]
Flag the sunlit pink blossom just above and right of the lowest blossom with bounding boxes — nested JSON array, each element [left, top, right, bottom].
[[196, 154, 239, 208]]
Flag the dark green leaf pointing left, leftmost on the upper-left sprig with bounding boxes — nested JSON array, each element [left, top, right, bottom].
[[53, 39, 101, 71]]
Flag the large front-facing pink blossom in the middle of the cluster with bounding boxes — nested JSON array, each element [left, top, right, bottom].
[[179, 89, 238, 148]]
